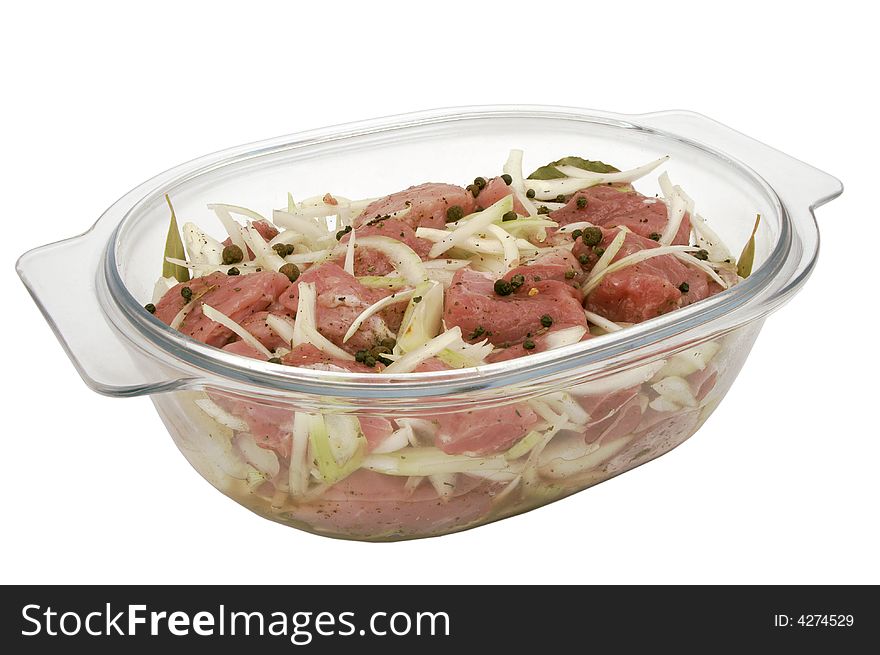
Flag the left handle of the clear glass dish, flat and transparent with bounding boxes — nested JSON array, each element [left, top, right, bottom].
[[15, 228, 186, 396]]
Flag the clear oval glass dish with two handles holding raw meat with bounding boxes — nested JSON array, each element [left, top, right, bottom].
[[17, 106, 842, 541]]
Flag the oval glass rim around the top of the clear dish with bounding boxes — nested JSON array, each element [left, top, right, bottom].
[[99, 105, 800, 398]]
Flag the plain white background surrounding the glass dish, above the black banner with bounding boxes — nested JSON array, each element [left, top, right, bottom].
[[0, 0, 880, 584]]
